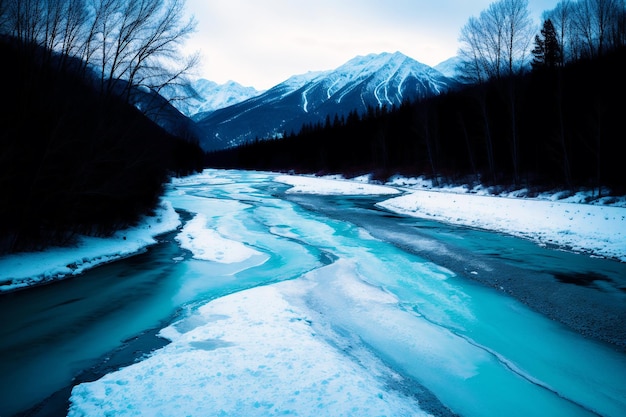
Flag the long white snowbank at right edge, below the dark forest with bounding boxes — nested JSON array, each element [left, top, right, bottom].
[[379, 191, 626, 262]]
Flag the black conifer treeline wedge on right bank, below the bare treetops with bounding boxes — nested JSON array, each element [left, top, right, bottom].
[[207, 47, 626, 192]]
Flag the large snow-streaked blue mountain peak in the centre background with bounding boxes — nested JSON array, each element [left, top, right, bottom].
[[195, 52, 458, 151]]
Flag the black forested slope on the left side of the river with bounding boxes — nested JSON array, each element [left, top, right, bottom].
[[0, 37, 204, 253]]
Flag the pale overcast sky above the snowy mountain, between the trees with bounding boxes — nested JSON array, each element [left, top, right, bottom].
[[186, 0, 558, 90]]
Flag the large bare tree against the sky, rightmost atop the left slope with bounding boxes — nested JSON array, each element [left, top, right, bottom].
[[74, 0, 197, 99]]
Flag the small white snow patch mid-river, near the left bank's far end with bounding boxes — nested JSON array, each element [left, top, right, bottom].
[[176, 214, 261, 263]]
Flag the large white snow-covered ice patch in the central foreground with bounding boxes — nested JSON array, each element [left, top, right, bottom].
[[68, 260, 427, 417]]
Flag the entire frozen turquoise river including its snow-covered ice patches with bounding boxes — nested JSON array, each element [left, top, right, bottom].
[[0, 171, 626, 417]]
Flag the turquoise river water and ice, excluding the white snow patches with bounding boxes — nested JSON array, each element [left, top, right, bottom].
[[0, 171, 626, 416]]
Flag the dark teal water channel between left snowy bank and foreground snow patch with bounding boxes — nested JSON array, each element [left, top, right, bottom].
[[0, 229, 188, 416]]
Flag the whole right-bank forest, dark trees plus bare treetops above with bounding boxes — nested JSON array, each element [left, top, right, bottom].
[[207, 0, 626, 194]]
